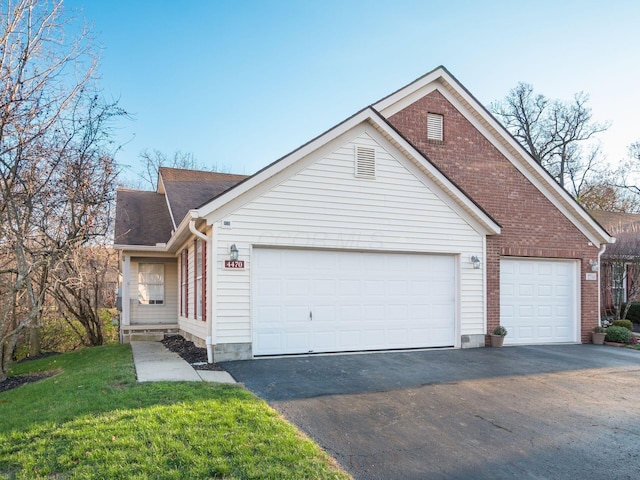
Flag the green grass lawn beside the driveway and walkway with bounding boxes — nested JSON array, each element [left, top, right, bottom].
[[0, 345, 351, 480]]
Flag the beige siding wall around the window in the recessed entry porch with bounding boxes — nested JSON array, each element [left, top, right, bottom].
[[129, 258, 178, 325]]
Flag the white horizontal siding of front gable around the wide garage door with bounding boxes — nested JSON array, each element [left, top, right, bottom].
[[211, 128, 485, 343]]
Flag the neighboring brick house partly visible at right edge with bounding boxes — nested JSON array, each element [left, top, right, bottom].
[[589, 210, 640, 319]]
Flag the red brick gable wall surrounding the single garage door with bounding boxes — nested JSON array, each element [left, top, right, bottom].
[[389, 91, 598, 343]]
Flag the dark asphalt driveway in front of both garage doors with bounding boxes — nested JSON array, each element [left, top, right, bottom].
[[223, 345, 640, 480]]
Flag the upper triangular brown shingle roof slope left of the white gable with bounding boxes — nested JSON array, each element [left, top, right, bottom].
[[158, 167, 247, 229]]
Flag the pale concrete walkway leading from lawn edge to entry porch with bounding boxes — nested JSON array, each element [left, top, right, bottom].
[[131, 341, 236, 383]]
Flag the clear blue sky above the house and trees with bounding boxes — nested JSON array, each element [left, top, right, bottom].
[[65, 0, 640, 186]]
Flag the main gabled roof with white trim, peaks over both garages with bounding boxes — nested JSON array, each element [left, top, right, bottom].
[[116, 67, 615, 250]]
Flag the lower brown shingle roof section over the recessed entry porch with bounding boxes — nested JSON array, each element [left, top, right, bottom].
[[114, 189, 173, 246]]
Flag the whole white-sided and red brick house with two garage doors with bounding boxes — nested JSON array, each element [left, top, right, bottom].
[[115, 67, 613, 361]]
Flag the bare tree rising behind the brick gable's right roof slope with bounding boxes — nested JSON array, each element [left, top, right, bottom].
[[490, 82, 609, 195]]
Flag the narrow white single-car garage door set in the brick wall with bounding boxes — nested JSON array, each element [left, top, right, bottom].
[[500, 258, 578, 345]]
